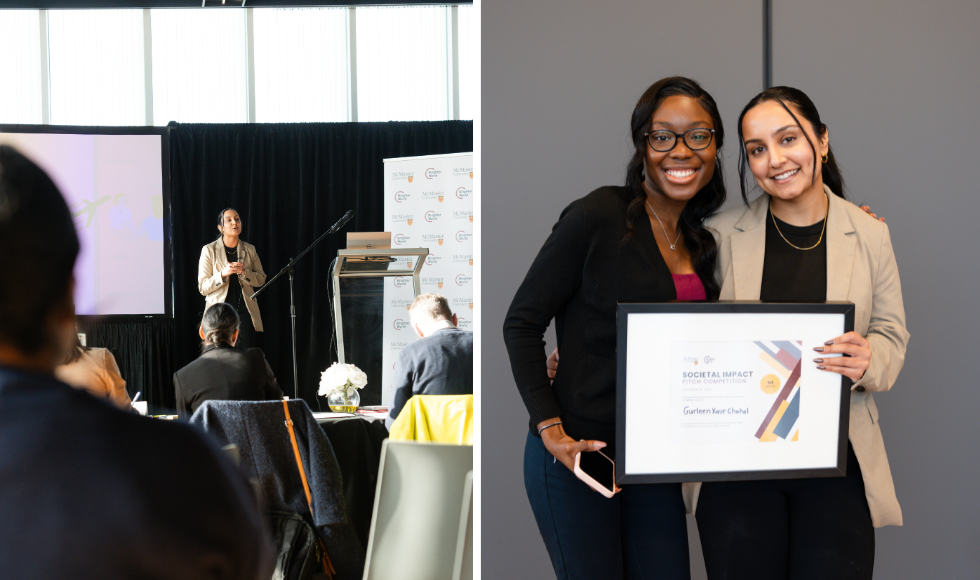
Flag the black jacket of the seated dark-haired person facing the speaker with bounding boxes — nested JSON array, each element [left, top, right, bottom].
[[174, 342, 282, 418]]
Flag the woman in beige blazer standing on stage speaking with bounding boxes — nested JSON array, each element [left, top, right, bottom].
[[197, 208, 265, 348]]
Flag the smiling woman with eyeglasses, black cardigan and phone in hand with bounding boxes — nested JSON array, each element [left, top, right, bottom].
[[504, 77, 726, 579]]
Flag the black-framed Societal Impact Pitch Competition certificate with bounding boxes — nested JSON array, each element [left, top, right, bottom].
[[616, 302, 854, 484]]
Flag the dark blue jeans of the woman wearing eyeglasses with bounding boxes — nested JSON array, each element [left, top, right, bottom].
[[524, 432, 691, 580]]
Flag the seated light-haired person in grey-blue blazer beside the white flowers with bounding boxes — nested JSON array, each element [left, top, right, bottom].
[[386, 293, 473, 427]]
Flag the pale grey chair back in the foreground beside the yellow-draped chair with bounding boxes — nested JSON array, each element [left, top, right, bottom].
[[364, 440, 473, 580]]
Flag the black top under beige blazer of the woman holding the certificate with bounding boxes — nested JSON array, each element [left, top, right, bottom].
[[759, 212, 827, 302]]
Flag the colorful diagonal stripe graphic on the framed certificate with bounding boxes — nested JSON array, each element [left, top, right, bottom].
[[755, 340, 803, 443]]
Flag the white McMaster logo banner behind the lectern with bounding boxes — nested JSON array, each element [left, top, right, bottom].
[[381, 153, 474, 405]]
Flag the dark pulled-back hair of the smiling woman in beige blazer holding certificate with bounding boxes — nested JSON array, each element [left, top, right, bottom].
[[738, 87, 847, 205]]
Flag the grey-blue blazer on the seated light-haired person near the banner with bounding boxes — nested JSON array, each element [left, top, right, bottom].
[[387, 328, 473, 427]]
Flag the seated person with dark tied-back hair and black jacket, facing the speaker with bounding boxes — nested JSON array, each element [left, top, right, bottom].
[[174, 302, 282, 418]]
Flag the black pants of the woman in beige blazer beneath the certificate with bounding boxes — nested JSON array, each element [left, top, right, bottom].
[[697, 443, 875, 580]]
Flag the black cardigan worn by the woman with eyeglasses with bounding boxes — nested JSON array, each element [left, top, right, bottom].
[[504, 186, 677, 448]]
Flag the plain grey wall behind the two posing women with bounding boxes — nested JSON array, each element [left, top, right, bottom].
[[481, 0, 980, 579]]
